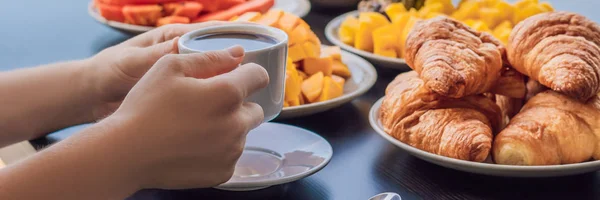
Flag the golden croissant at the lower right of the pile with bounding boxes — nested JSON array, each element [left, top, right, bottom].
[[493, 90, 600, 165]]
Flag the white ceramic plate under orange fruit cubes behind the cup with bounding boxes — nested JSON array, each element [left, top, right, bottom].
[[277, 46, 377, 119]]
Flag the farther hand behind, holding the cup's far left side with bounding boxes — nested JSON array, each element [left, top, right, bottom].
[[87, 21, 233, 119]]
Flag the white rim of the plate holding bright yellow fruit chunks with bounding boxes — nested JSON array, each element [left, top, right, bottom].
[[325, 10, 406, 68]]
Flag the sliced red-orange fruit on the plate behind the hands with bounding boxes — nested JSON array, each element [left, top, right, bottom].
[[94, 0, 275, 26]]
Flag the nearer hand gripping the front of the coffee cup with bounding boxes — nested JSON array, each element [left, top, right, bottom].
[[106, 46, 269, 189]]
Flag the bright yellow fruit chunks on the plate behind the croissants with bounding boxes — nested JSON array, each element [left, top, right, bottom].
[[338, 0, 554, 58]]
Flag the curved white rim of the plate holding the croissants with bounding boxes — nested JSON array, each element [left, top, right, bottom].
[[369, 97, 600, 174]]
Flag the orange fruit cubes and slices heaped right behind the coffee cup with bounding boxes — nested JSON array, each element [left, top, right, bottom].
[[230, 9, 352, 107]]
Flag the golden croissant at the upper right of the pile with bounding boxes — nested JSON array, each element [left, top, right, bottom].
[[507, 12, 600, 101]]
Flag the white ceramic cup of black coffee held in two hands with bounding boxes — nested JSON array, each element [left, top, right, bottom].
[[177, 24, 288, 122]]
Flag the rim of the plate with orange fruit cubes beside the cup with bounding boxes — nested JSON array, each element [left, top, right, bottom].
[[281, 45, 379, 113]]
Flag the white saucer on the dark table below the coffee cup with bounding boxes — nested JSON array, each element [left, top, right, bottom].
[[217, 123, 333, 191]]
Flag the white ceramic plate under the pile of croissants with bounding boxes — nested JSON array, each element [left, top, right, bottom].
[[369, 98, 600, 177]]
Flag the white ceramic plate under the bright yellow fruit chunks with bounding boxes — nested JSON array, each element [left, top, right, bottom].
[[325, 11, 410, 70]]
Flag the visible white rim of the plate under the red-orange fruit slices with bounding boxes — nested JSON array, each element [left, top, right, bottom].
[[88, 0, 312, 33]]
